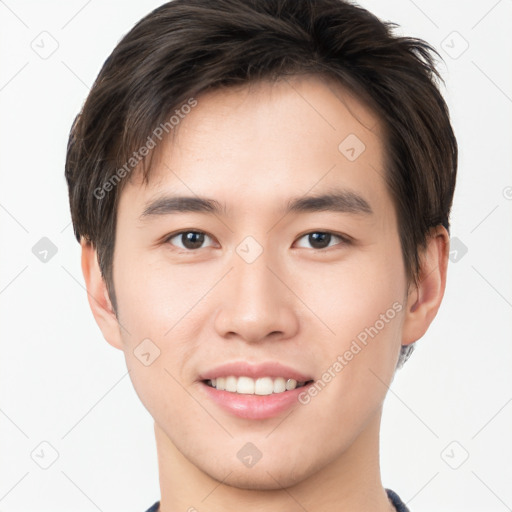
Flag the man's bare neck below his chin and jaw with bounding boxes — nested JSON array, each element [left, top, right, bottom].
[[155, 410, 394, 512]]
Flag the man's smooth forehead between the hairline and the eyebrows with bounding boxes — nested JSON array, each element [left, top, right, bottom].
[[123, 76, 386, 219]]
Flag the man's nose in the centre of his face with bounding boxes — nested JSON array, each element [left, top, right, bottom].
[[215, 244, 299, 343]]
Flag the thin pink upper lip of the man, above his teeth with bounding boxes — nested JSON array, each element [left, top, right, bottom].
[[199, 361, 313, 382]]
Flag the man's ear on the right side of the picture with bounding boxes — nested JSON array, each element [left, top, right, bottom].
[[402, 225, 450, 345]]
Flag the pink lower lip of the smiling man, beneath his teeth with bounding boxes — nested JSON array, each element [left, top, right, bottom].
[[201, 382, 309, 420]]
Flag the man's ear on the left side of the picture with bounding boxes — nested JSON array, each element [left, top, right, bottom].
[[81, 241, 123, 350]]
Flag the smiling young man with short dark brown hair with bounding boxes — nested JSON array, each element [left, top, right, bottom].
[[66, 0, 457, 512]]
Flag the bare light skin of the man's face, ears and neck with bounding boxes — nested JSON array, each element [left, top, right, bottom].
[[82, 73, 449, 512]]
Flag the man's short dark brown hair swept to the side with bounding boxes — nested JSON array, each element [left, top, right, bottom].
[[65, 0, 457, 364]]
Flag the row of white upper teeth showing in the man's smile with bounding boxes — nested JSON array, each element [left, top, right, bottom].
[[204, 375, 305, 395]]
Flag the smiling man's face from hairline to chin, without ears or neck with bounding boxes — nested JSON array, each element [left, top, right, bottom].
[[113, 77, 407, 489]]
